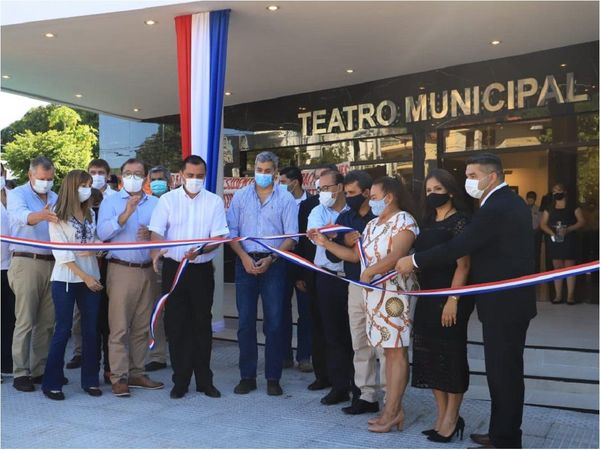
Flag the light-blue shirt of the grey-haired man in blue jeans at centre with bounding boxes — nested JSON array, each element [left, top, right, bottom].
[[227, 183, 298, 253]]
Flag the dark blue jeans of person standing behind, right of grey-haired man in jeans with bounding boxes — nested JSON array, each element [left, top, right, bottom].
[[283, 263, 312, 362]]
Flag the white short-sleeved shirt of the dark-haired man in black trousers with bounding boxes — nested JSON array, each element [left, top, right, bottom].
[[148, 187, 229, 264]]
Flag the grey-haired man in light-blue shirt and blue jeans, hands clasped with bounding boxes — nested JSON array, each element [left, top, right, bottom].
[[227, 152, 298, 395]]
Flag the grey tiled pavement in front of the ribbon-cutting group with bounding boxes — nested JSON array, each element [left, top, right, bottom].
[[1, 341, 599, 448]]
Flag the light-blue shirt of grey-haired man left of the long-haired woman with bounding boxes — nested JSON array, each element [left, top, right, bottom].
[[7, 181, 58, 255]]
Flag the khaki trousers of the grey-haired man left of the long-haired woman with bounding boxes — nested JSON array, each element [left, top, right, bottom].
[[8, 256, 54, 378]]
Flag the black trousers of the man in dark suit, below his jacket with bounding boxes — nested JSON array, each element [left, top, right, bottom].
[[482, 321, 529, 448]]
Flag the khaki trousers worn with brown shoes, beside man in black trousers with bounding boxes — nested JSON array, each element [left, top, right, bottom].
[[106, 262, 159, 383]]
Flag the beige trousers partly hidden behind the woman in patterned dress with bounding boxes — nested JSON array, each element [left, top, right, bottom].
[[348, 284, 385, 402]]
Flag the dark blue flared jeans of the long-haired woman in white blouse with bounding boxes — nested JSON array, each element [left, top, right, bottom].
[[42, 281, 100, 391]]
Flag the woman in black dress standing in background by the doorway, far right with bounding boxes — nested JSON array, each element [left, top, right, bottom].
[[540, 183, 585, 305]]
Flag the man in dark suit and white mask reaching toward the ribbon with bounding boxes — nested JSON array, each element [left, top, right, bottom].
[[396, 153, 536, 448]]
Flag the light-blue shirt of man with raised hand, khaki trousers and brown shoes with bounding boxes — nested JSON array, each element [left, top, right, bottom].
[[97, 189, 158, 264]]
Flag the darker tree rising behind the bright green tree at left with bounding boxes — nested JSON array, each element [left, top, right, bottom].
[[1, 104, 100, 158]]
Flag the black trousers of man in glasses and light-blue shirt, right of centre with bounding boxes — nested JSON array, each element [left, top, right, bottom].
[[316, 273, 354, 390]]
